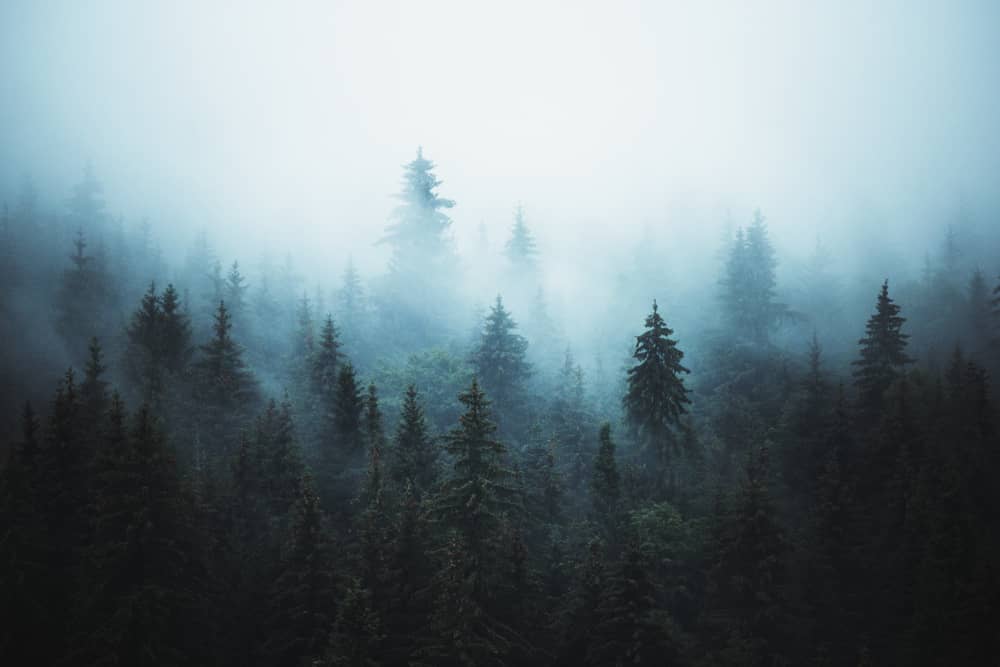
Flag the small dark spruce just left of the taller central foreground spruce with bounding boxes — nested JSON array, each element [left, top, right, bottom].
[[390, 384, 437, 500]]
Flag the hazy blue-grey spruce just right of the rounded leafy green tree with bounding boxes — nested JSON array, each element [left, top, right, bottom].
[[472, 295, 531, 435]]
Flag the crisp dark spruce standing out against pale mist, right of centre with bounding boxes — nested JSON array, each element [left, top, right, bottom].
[[622, 301, 691, 480]]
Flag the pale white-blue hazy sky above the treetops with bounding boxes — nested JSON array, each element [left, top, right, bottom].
[[0, 0, 1000, 276]]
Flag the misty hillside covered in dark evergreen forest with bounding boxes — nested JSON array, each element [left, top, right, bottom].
[[0, 151, 1000, 667]]
